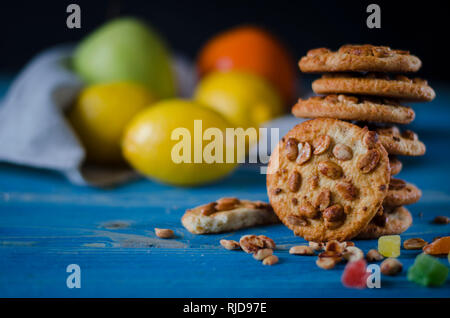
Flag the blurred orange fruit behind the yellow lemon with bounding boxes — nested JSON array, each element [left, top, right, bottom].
[[197, 26, 296, 103]]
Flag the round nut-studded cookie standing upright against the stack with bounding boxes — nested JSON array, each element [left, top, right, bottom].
[[267, 118, 390, 242]]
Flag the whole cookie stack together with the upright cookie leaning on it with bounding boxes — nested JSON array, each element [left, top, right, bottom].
[[267, 45, 435, 241]]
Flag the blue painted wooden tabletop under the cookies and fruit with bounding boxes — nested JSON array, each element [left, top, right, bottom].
[[0, 78, 450, 297]]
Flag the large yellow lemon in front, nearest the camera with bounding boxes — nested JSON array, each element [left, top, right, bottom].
[[122, 99, 236, 186]]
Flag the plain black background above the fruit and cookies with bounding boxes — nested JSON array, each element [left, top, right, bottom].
[[0, 0, 450, 80]]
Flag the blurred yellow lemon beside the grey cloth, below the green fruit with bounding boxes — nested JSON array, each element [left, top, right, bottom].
[[69, 82, 154, 164]]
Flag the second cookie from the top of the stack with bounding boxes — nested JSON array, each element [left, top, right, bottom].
[[312, 73, 436, 102]]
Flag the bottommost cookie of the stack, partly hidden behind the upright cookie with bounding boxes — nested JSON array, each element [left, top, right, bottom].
[[357, 206, 412, 239]]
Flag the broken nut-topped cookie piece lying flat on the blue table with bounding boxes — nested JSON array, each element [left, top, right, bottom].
[[181, 197, 280, 234]]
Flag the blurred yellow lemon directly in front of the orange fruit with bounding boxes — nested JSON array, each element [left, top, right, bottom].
[[194, 71, 284, 128]]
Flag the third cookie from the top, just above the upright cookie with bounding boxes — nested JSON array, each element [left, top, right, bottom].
[[292, 94, 415, 124]]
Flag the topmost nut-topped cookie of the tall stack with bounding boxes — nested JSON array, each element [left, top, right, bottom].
[[299, 44, 422, 73]]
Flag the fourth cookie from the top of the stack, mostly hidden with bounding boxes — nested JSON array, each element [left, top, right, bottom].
[[374, 126, 426, 156]]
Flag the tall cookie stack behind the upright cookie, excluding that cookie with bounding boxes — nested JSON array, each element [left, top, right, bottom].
[[292, 45, 435, 238]]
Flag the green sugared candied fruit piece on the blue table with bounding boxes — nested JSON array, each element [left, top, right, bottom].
[[408, 253, 448, 286]]
